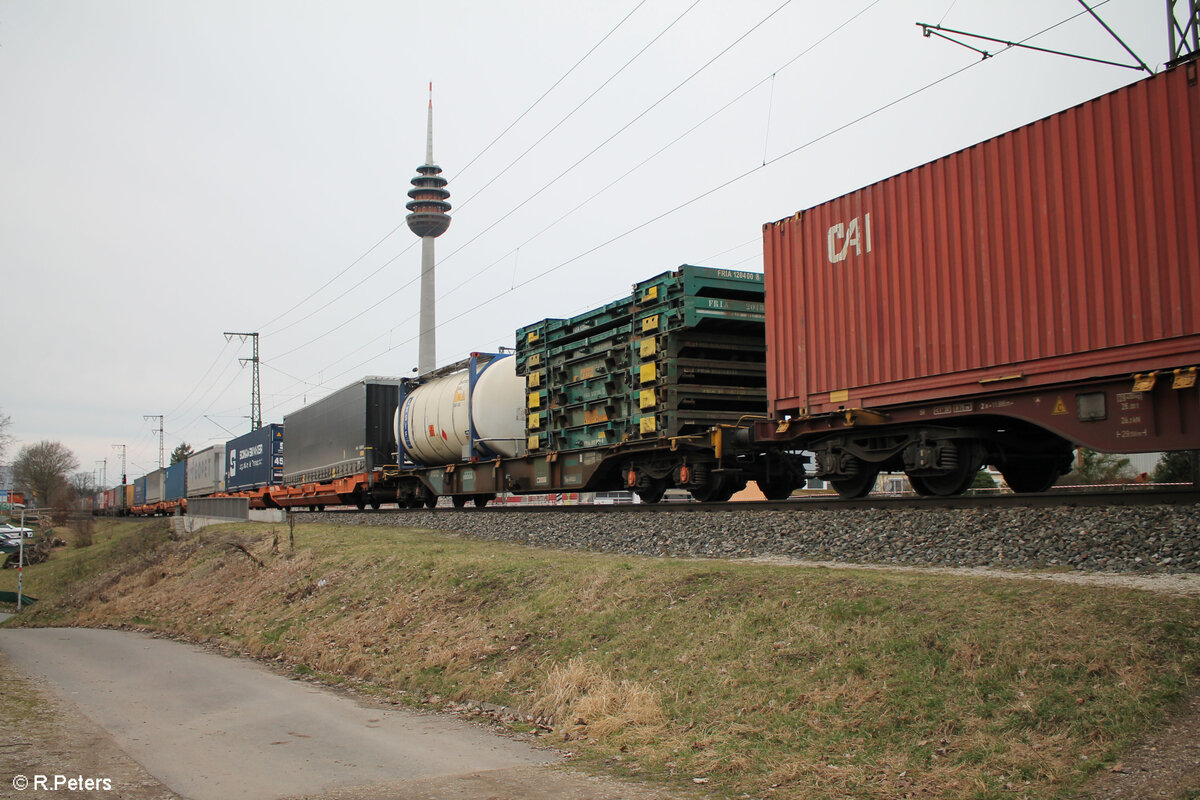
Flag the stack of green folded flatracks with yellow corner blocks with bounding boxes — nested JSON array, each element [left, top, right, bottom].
[[517, 265, 767, 452]]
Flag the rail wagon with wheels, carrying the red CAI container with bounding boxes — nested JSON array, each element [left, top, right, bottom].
[[760, 61, 1200, 494]]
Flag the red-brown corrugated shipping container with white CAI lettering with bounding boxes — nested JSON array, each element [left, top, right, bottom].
[[763, 61, 1200, 416]]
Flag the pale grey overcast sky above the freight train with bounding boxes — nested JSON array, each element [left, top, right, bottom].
[[0, 0, 1166, 485]]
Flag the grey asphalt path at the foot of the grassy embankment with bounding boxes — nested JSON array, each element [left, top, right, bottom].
[[0, 628, 676, 800]]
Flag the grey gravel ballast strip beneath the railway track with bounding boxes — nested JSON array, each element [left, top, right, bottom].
[[312, 505, 1200, 572]]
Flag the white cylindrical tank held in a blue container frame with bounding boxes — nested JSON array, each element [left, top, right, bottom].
[[395, 356, 524, 464]]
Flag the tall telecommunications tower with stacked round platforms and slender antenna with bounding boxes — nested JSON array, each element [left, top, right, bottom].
[[404, 83, 450, 375]]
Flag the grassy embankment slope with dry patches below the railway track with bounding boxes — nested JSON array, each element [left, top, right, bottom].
[[0, 522, 1200, 800]]
